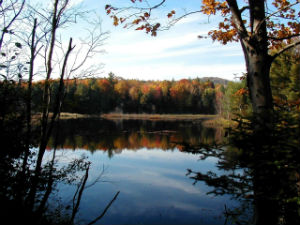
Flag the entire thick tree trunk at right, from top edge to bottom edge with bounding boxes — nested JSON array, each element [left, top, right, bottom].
[[240, 0, 279, 225]]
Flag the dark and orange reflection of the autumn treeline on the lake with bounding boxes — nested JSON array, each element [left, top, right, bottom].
[[48, 119, 220, 156]]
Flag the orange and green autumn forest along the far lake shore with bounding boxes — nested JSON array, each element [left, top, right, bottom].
[[29, 77, 222, 114]]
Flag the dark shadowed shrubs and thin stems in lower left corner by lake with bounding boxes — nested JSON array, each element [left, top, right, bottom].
[[0, 117, 119, 225]]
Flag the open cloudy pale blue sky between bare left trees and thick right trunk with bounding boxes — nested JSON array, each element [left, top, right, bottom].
[[52, 0, 245, 80]]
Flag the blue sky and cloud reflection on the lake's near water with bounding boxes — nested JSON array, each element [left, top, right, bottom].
[[44, 149, 238, 224]]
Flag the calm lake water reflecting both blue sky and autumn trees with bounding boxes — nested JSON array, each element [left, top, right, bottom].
[[45, 119, 244, 224]]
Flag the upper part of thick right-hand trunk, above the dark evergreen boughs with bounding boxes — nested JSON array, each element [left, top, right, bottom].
[[240, 0, 273, 124]]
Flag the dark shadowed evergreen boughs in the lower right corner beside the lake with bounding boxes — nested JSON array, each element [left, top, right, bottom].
[[186, 113, 300, 224]]
